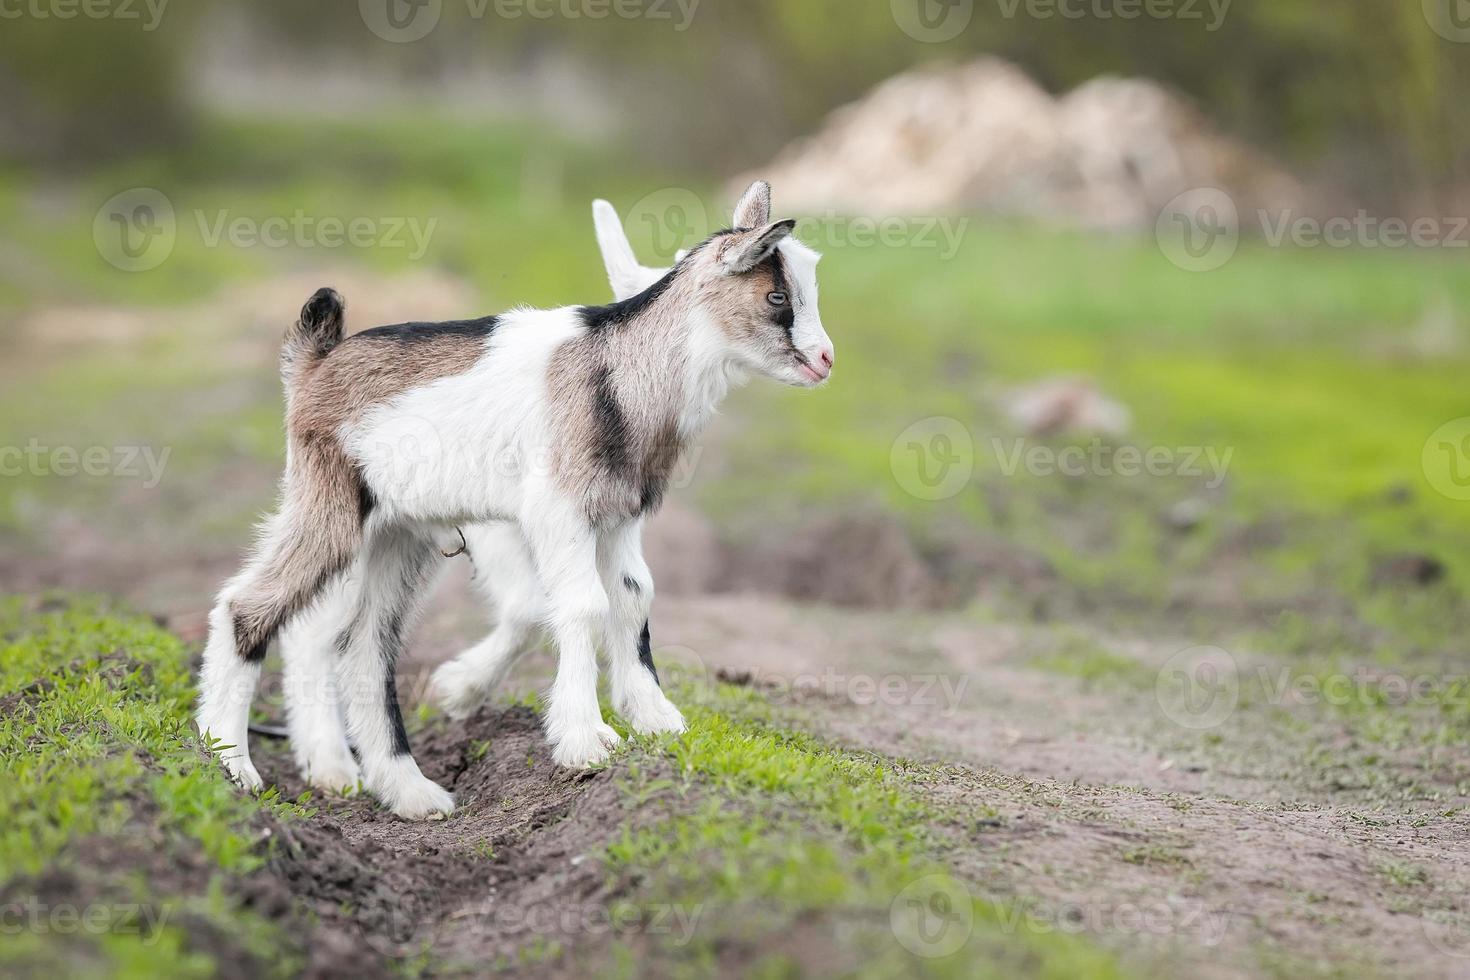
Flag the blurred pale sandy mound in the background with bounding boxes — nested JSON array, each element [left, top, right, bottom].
[[736, 57, 1322, 229]]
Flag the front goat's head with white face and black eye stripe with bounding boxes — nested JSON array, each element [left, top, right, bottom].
[[678, 181, 833, 388]]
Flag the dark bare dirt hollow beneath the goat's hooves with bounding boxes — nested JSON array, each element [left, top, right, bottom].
[[249, 707, 685, 976]]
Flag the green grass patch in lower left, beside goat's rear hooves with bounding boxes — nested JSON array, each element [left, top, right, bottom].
[[0, 598, 304, 976]]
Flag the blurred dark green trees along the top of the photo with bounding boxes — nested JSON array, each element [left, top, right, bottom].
[[0, 0, 1470, 200]]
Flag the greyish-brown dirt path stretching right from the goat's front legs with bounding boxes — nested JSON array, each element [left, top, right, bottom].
[[657, 598, 1470, 977]]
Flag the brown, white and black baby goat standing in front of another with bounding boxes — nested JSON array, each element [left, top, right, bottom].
[[197, 182, 832, 818]]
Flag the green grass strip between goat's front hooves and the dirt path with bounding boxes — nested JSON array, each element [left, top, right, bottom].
[[596, 675, 1125, 977]]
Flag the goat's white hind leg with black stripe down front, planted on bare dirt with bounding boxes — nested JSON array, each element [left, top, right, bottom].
[[337, 527, 454, 820]]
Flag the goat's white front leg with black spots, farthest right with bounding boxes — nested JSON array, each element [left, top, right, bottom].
[[598, 520, 684, 735]]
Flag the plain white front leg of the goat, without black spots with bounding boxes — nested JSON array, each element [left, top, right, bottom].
[[525, 513, 620, 768]]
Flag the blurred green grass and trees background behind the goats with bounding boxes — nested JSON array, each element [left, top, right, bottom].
[[0, 0, 1470, 658]]
